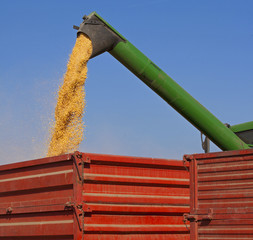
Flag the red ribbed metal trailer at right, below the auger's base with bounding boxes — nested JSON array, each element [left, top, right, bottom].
[[184, 149, 253, 240]]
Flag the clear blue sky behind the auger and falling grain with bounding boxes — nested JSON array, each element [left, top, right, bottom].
[[0, 0, 253, 164]]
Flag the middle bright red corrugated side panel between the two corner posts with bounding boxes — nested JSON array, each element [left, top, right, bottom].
[[83, 154, 189, 240]]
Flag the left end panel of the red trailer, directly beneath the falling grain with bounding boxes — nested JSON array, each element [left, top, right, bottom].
[[0, 155, 73, 240]]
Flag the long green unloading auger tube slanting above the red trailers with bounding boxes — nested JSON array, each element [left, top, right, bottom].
[[79, 12, 249, 151]]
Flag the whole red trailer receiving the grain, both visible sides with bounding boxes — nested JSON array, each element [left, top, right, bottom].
[[0, 152, 190, 240]]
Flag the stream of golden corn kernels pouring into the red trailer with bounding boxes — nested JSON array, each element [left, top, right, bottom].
[[47, 34, 92, 156]]
